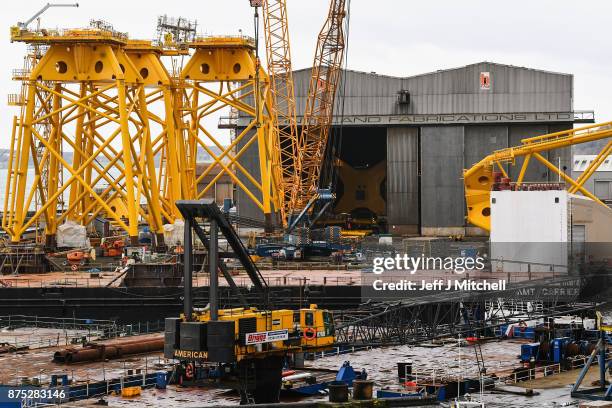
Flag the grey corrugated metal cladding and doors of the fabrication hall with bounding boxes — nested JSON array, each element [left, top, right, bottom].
[[236, 63, 573, 233]]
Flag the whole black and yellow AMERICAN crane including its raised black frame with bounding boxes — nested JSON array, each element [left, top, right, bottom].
[[164, 200, 335, 403]]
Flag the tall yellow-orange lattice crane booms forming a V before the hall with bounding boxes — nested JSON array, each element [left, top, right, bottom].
[[258, 0, 346, 231]]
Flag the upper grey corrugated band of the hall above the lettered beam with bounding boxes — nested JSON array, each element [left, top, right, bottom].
[[294, 62, 573, 115]]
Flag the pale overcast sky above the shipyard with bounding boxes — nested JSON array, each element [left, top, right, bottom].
[[0, 0, 612, 147]]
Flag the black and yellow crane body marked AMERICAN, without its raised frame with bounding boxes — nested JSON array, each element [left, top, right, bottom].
[[164, 305, 335, 403]]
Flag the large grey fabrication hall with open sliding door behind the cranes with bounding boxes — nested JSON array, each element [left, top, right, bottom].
[[236, 62, 593, 236]]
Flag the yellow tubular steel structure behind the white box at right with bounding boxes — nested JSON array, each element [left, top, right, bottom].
[[463, 122, 612, 231]]
